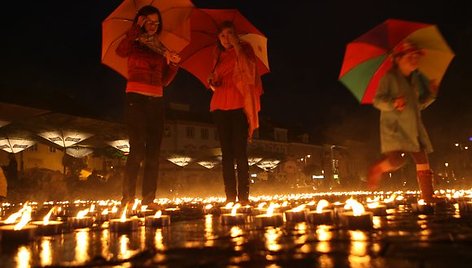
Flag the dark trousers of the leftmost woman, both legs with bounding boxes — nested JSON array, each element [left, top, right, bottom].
[[122, 93, 164, 204]]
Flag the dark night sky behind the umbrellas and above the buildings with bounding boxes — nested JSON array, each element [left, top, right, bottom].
[[0, 0, 472, 147]]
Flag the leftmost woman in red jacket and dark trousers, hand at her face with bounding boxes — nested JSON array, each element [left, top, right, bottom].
[[116, 6, 180, 208]]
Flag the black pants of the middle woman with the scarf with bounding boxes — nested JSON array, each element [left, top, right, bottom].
[[213, 109, 249, 202]]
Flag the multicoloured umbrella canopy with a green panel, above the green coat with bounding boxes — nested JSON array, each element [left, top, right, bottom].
[[339, 19, 454, 104]]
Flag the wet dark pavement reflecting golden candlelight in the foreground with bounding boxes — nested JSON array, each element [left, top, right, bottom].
[[0, 189, 472, 267]]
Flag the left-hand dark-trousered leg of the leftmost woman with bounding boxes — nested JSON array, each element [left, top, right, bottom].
[[121, 93, 145, 204]]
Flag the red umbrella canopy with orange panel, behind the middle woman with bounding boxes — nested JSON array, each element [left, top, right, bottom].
[[181, 8, 269, 87]]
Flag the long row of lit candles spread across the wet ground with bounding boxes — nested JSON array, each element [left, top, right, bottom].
[[0, 189, 472, 244]]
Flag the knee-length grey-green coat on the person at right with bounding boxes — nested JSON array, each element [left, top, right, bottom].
[[373, 67, 436, 153]]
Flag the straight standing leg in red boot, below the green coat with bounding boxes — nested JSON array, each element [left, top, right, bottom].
[[411, 151, 435, 203]]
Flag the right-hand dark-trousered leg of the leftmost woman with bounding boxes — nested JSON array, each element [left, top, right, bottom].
[[141, 98, 164, 205]]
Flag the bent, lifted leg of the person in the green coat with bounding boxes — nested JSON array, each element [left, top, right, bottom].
[[367, 151, 405, 190]]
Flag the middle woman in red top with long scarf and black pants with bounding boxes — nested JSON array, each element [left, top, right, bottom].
[[209, 21, 262, 203]]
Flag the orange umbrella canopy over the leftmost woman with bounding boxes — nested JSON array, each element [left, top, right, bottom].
[[102, 0, 193, 77]]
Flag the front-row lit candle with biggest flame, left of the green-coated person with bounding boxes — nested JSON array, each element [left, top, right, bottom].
[[340, 199, 373, 229]]
